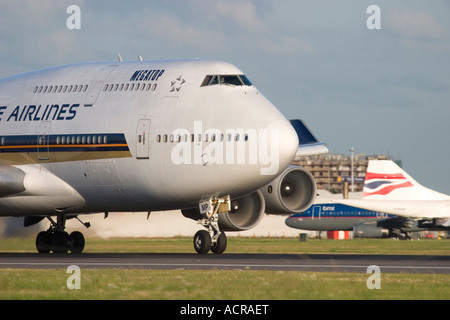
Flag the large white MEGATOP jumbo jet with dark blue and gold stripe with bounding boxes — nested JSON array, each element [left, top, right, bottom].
[[0, 59, 327, 253]]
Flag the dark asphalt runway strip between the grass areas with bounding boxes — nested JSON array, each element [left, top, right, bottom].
[[0, 253, 450, 273]]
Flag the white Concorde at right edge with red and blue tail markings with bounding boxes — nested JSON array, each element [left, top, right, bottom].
[[337, 160, 450, 230]]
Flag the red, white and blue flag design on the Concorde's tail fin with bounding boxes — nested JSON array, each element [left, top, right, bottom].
[[363, 172, 413, 197]]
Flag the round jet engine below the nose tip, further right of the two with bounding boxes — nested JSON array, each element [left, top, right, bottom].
[[260, 166, 317, 214]]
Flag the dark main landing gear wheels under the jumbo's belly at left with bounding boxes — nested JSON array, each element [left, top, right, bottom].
[[36, 215, 90, 253]]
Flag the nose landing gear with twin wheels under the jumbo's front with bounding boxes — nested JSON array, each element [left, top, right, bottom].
[[194, 196, 231, 254]]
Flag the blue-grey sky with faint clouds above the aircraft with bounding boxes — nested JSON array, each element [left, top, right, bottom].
[[0, 0, 450, 194]]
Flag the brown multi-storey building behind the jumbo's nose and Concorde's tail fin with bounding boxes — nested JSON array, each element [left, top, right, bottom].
[[292, 154, 401, 193]]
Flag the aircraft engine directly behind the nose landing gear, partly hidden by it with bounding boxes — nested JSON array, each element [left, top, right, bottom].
[[181, 191, 265, 231]]
